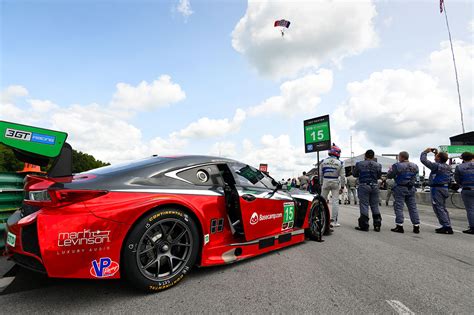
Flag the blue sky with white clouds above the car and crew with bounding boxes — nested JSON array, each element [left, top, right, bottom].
[[0, 0, 474, 176]]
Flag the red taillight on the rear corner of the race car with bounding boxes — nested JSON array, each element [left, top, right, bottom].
[[25, 189, 107, 207]]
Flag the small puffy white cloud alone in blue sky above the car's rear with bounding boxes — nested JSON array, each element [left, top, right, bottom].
[[111, 75, 186, 111]]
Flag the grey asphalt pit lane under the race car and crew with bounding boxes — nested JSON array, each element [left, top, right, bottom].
[[0, 206, 474, 314]]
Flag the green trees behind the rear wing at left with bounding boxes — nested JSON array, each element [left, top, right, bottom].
[[0, 144, 110, 173]]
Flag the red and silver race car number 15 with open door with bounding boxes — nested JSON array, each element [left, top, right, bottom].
[[7, 156, 329, 291]]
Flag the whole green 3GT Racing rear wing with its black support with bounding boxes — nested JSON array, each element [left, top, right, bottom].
[[0, 121, 72, 177]]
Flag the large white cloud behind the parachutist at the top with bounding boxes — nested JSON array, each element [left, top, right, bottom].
[[232, 0, 377, 78]]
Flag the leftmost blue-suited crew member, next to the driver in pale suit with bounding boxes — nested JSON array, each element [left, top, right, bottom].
[[354, 150, 382, 232]]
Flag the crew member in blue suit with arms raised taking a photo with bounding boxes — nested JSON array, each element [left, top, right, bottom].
[[420, 148, 453, 234]]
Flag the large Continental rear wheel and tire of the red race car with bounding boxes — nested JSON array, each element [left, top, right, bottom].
[[122, 208, 199, 292]]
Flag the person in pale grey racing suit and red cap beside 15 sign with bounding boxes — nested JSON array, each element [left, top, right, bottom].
[[320, 143, 345, 227]]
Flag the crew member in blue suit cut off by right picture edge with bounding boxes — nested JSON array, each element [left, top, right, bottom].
[[454, 152, 474, 234]]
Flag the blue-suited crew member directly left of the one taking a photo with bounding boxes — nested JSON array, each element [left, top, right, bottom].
[[387, 151, 420, 234]]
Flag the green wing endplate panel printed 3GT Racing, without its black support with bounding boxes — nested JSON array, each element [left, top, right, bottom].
[[0, 121, 67, 158]]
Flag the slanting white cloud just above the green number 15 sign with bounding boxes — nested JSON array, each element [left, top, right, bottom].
[[248, 69, 333, 116]]
